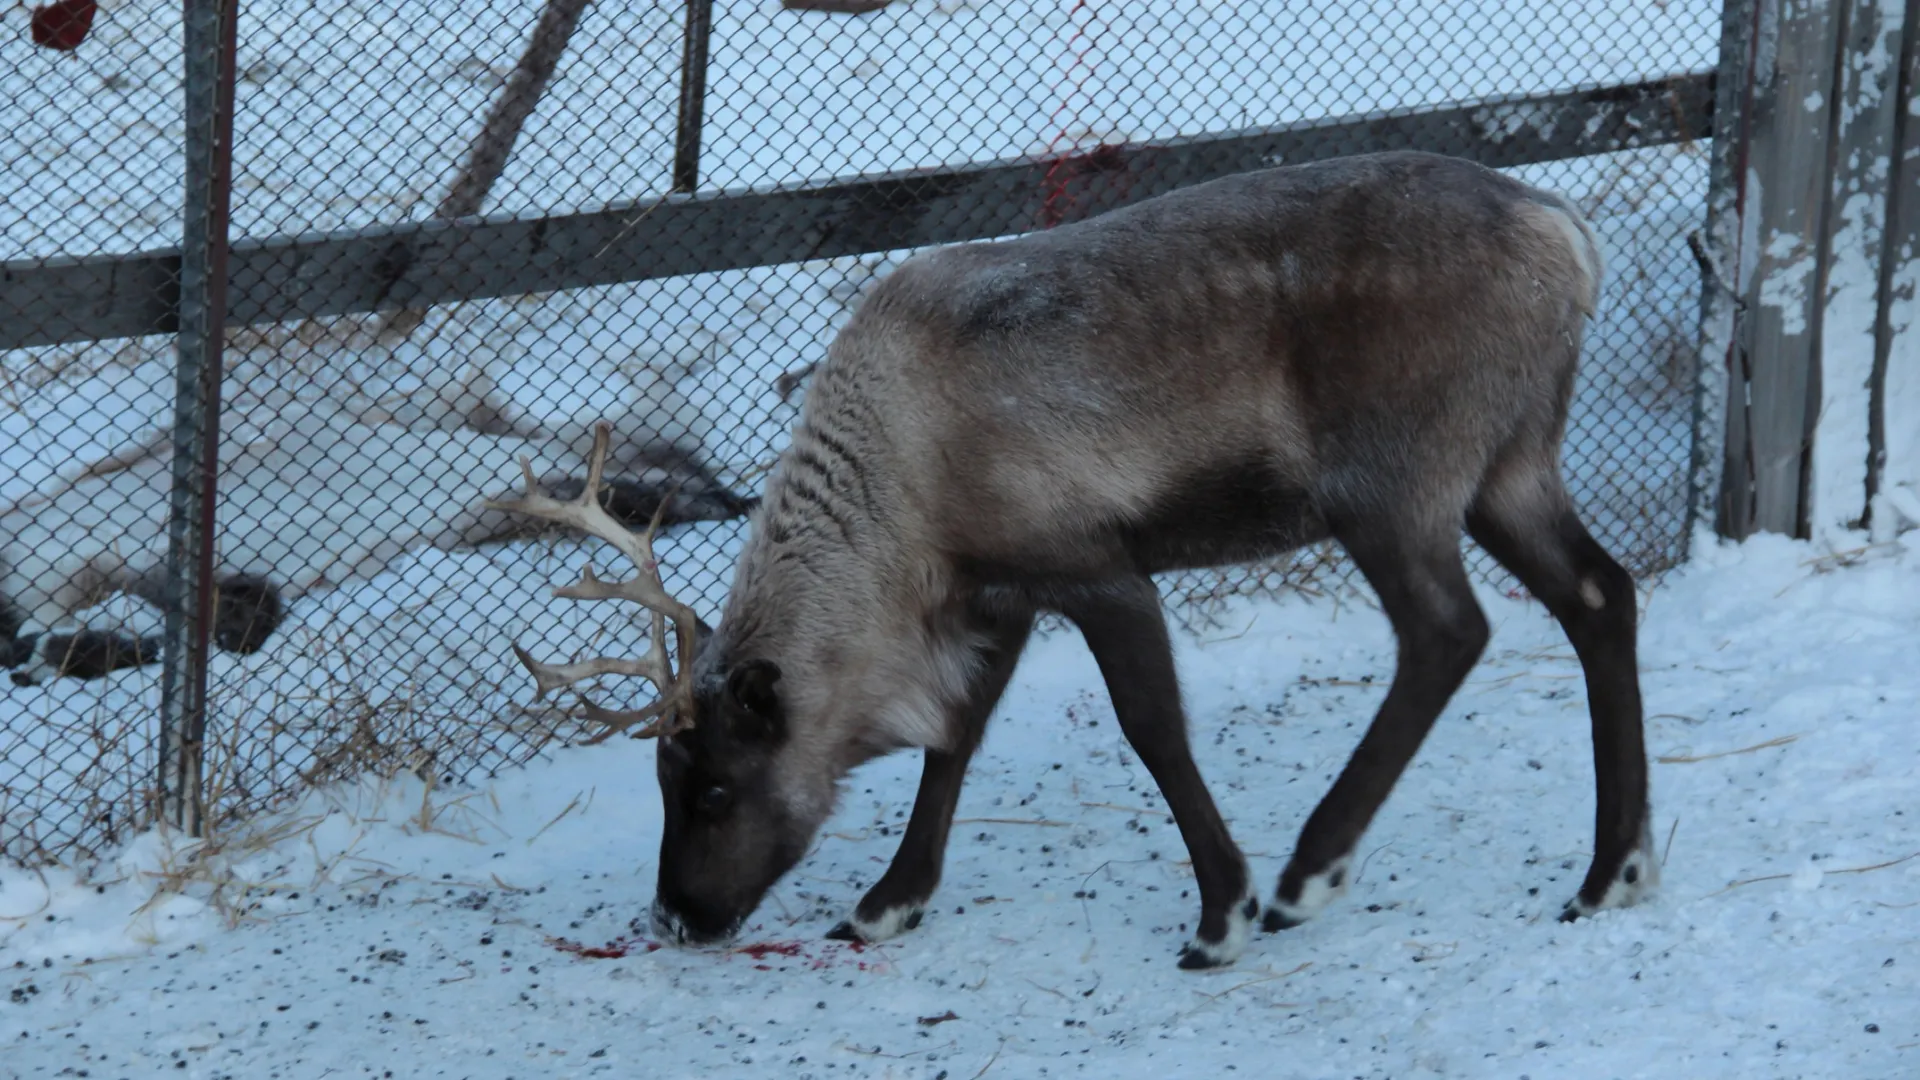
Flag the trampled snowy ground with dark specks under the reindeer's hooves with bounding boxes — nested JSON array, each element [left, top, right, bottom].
[[0, 532, 1920, 1080]]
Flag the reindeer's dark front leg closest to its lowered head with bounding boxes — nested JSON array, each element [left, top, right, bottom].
[[828, 613, 1033, 942]]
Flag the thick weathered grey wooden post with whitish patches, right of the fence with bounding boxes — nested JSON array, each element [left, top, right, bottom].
[[1720, 0, 1914, 538]]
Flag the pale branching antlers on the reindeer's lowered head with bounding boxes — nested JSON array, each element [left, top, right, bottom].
[[486, 421, 699, 744]]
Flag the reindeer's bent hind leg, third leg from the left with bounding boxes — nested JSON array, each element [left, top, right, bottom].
[[1261, 519, 1488, 932]]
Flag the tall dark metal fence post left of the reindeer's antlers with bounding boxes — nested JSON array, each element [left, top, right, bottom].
[[159, 0, 238, 836]]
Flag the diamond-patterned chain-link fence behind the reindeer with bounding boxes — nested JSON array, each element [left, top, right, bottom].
[[0, 0, 1718, 859]]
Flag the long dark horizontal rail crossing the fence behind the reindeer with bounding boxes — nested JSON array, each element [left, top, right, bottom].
[[0, 71, 1715, 348]]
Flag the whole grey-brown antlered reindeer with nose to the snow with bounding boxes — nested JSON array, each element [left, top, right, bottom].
[[499, 152, 1657, 969]]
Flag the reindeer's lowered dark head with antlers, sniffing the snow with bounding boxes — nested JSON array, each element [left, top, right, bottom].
[[488, 423, 828, 944]]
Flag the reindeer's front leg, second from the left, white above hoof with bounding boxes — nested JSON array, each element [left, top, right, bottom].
[[1064, 578, 1260, 969]]
